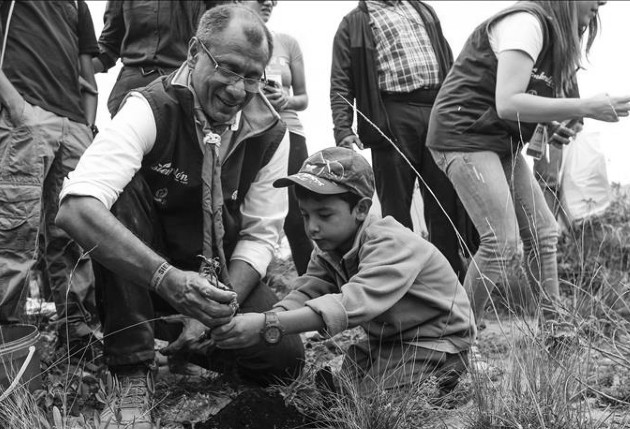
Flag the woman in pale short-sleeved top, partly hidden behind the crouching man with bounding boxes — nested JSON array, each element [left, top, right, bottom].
[[237, 0, 313, 275]]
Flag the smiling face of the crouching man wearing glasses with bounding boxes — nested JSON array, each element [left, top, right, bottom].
[[189, 20, 268, 124]]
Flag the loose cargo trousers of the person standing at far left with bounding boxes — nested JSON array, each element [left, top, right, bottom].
[[0, 103, 94, 337]]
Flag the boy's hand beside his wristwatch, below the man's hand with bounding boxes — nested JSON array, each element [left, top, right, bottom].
[[211, 313, 265, 349]]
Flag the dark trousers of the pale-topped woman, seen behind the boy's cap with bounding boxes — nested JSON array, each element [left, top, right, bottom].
[[284, 133, 313, 276]]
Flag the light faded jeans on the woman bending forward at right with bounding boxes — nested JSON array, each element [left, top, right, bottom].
[[432, 151, 559, 320]]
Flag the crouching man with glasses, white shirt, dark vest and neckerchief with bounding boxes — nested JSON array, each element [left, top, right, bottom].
[[57, 5, 304, 428]]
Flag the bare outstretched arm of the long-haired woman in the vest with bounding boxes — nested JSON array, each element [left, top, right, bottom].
[[496, 50, 630, 122]]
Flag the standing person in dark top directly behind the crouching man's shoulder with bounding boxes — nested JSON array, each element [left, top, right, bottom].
[[92, 0, 217, 116]]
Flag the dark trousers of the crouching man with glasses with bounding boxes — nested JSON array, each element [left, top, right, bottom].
[[95, 175, 304, 384]]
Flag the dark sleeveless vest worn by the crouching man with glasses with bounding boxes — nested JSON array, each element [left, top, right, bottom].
[[140, 75, 286, 270]]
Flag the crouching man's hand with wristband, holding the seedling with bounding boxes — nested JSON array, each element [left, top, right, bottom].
[[158, 268, 236, 328]]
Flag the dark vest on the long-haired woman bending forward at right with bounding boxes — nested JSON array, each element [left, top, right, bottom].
[[427, 2, 556, 155]]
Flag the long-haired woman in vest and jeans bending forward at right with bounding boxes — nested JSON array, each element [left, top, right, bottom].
[[427, 1, 630, 323]]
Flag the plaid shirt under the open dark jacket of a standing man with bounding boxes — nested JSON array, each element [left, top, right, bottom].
[[366, 1, 441, 92]]
